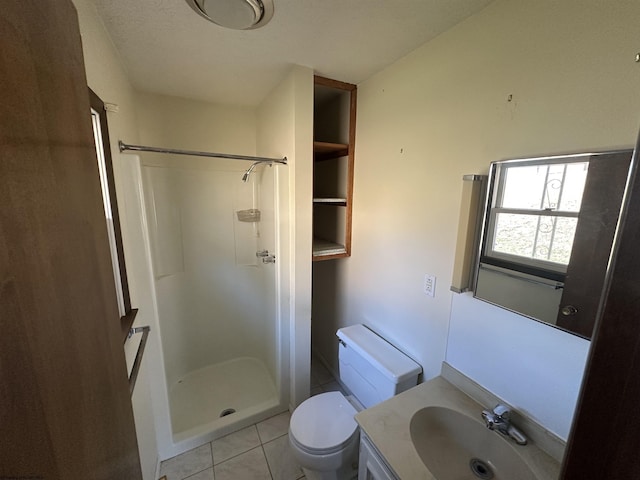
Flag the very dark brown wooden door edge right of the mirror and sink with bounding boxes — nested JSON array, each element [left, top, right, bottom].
[[560, 142, 640, 480]]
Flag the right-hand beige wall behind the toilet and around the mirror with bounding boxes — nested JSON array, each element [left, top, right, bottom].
[[313, 0, 640, 436]]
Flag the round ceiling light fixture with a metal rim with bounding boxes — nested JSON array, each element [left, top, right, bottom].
[[187, 0, 273, 30]]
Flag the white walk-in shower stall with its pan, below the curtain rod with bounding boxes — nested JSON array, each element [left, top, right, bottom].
[[141, 145, 286, 443]]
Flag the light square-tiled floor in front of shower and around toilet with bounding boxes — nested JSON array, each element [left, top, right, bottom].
[[160, 359, 342, 480]]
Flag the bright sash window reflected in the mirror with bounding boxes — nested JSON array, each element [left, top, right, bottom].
[[483, 158, 589, 279]]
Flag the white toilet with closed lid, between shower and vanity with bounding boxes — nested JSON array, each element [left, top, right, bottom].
[[289, 325, 422, 480]]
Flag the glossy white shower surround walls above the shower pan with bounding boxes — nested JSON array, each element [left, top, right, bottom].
[[143, 158, 277, 388]]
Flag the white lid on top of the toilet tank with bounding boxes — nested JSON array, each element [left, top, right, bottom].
[[336, 325, 422, 383]]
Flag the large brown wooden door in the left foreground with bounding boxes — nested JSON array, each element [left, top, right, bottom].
[[0, 0, 141, 480]]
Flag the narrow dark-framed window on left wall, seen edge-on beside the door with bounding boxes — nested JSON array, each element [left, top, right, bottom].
[[89, 89, 138, 339]]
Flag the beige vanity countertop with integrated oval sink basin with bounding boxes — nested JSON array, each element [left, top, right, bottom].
[[356, 374, 564, 480]]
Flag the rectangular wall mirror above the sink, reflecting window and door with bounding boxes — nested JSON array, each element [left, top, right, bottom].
[[474, 150, 632, 339]]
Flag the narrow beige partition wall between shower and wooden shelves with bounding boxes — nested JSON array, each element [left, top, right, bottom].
[[257, 66, 313, 407]]
